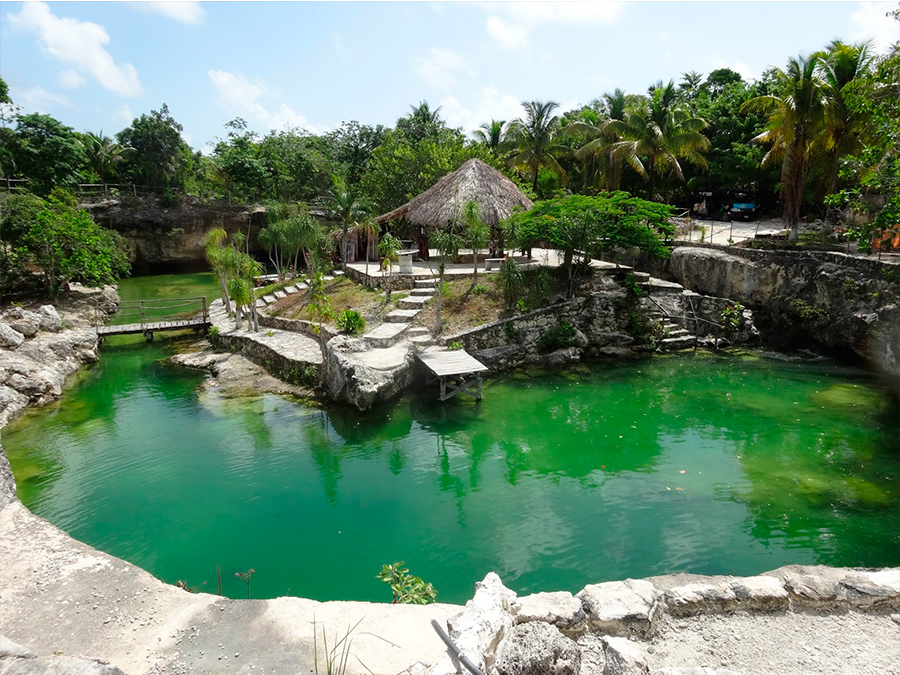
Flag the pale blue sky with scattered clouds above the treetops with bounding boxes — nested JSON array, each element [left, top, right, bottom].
[[0, 1, 900, 149]]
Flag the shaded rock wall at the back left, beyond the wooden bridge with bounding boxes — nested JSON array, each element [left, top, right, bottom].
[[82, 197, 265, 273]]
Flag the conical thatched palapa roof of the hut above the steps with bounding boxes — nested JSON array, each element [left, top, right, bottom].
[[375, 159, 534, 227]]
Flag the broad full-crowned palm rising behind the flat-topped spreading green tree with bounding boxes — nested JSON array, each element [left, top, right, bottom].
[[604, 80, 709, 199]]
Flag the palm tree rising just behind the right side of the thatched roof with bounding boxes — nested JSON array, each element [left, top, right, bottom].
[[506, 101, 567, 192]]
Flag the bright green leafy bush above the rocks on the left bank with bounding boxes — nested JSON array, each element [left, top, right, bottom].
[[18, 199, 130, 298]]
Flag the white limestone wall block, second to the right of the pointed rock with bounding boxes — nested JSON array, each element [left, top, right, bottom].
[[578, 579, 659, 637]]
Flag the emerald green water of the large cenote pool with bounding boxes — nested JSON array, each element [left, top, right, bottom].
[[3, 277, 900, 602]]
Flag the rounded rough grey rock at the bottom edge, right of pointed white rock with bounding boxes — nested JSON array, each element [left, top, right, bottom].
[[493, 621, 581, 675]]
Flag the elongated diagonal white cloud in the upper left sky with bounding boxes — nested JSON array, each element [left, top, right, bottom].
[[8, 2, 142, 96]]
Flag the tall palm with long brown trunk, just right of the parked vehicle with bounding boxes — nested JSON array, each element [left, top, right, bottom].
[[741, 54, 826, 240]]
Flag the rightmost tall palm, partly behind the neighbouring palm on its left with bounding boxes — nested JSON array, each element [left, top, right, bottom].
[[819, 40, 872, 194]]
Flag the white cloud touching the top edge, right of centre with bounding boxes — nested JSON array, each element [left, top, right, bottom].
[[485, 0, 624, 49]]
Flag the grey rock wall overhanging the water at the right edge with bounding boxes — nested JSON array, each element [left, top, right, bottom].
[[631, 246, 900, 382]]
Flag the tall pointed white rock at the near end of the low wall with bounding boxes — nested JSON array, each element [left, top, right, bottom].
[[430, 572, 518, 675]]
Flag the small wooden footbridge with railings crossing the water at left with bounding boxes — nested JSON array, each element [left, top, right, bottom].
[[94, 295, 211, 342]]
